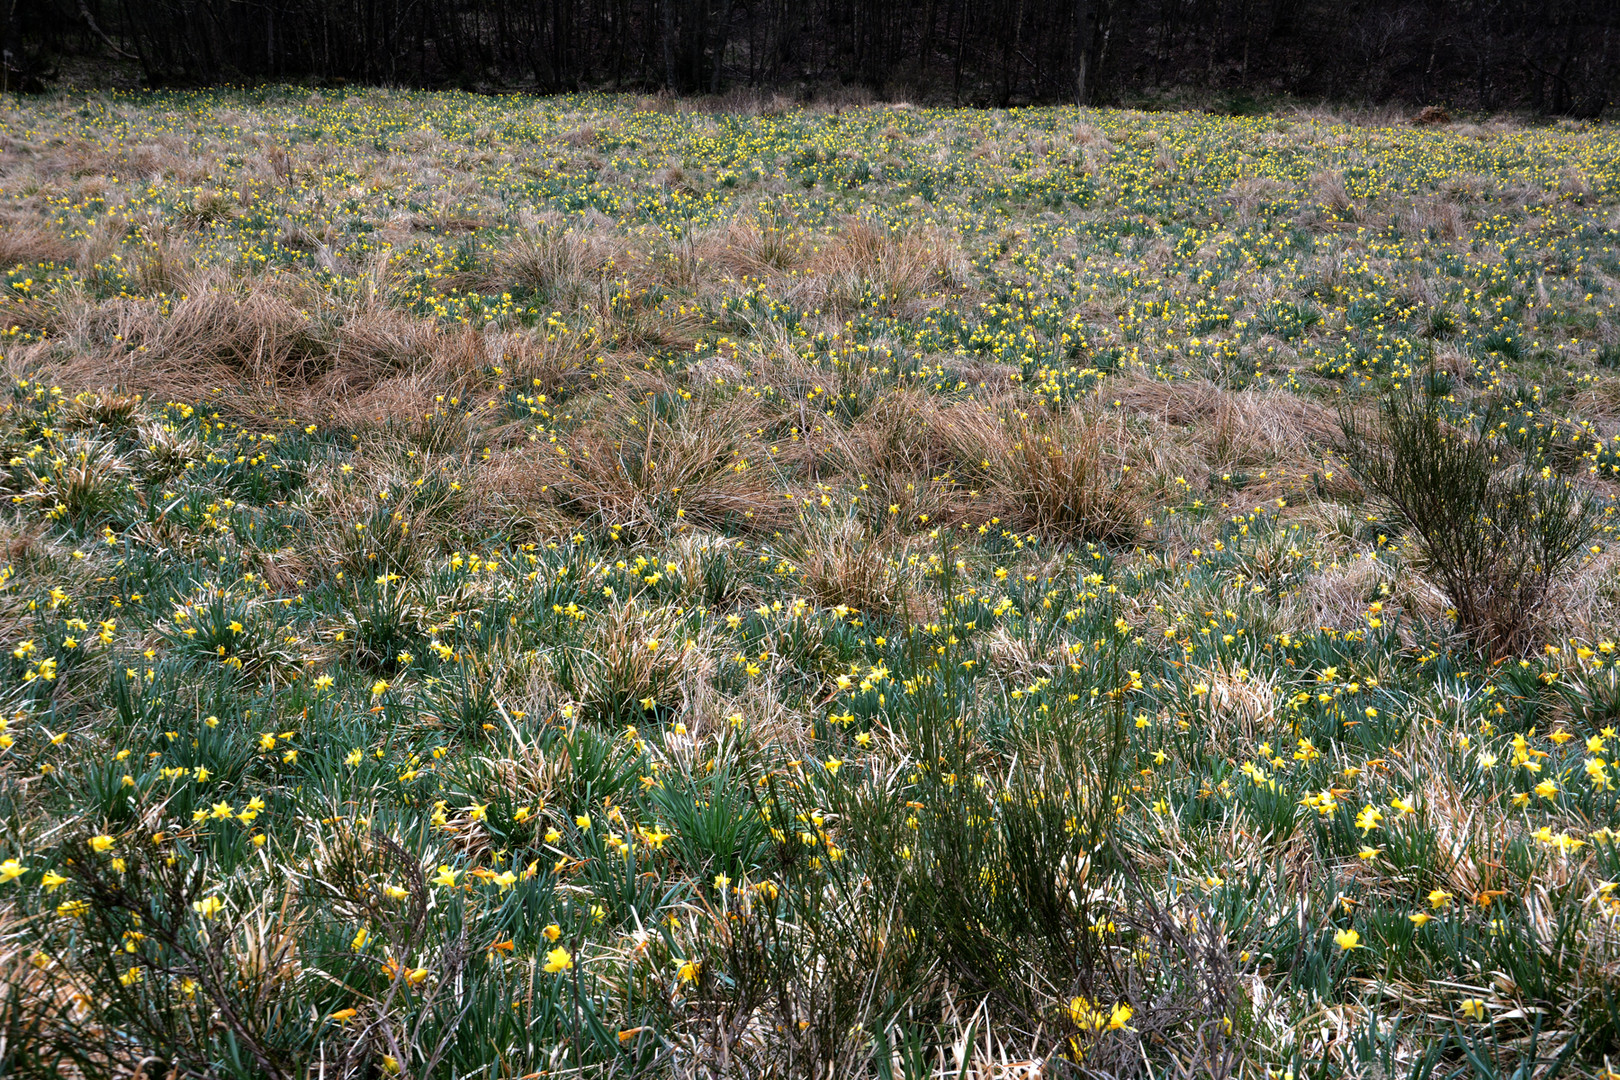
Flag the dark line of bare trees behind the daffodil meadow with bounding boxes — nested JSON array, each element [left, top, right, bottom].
[[0, 0, 1620, 115]]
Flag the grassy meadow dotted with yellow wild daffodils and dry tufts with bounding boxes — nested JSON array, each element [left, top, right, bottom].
[[0, 89, 1620, 1080]]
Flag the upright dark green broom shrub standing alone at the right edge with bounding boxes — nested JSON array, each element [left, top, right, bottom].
[[1341, 393, 1601, 657]]
